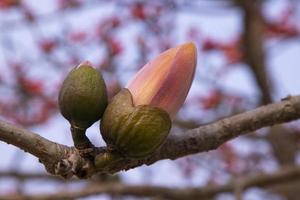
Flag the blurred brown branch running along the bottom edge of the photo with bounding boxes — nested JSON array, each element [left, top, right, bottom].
[[0, 166, 300, 200]]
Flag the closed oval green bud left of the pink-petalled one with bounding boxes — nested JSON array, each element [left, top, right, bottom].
[[58, 62, 107, 129]]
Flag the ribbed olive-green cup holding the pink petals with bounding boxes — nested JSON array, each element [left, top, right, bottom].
[[100, 89, 171, 158]]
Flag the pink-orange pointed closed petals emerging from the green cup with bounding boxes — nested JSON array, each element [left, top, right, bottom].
[[127, 42, 197, 118]]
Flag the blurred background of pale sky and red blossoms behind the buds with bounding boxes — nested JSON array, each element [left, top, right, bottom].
[[0, 0, 300, 200]]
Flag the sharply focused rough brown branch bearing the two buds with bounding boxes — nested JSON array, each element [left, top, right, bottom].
[[0, 96, 300, 178]]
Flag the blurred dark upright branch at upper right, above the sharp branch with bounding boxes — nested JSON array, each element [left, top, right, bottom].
[[236, 0, 273, 104]]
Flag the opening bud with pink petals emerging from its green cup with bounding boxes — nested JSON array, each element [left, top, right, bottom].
[[96, 43, 196, 161]]
